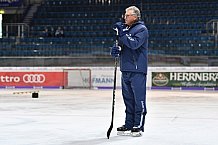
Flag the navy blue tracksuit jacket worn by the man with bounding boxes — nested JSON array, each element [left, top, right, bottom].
[[119, 21, 148, 74]]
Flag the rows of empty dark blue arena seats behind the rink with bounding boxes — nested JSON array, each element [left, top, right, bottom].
[[0, 0, 218, 56]]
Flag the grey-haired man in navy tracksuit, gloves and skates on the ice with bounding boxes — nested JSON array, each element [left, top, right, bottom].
[[111, 6, 148, 136]]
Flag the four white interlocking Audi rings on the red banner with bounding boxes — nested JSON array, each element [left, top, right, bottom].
[[23, 74, 45, 83]]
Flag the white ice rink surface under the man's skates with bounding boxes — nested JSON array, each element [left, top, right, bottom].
[[0, 89, 218, 145]]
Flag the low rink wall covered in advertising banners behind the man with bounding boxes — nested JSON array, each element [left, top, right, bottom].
[[0, 67, 218, 90]]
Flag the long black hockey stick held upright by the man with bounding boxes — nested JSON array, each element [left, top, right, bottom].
[[107, 28, 118, 139]]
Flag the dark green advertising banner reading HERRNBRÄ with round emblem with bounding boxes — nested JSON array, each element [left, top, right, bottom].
[[152, 72, 218, 87]]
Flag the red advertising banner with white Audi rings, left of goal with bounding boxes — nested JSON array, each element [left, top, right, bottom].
[[0, 72, 64, 87]]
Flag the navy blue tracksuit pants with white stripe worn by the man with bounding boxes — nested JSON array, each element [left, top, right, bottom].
[[121, 72, 147, 131]]
